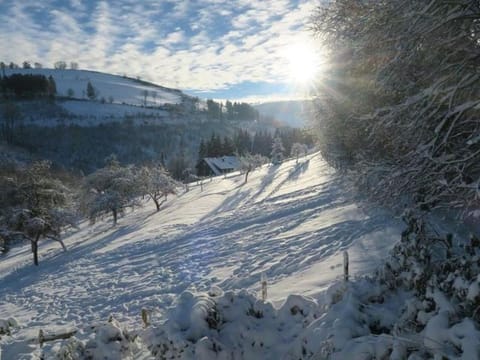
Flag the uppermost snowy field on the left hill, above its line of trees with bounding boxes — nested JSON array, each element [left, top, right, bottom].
[[5, 69, 182, 105]]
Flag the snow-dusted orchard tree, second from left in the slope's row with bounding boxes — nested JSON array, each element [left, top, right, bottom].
[[81, 157, 141, 225]]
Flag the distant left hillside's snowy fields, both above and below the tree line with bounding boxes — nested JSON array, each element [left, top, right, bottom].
[[5, 69, 195, 126]]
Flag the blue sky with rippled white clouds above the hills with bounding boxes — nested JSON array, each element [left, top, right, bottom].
[[0, 0, 318, 100]]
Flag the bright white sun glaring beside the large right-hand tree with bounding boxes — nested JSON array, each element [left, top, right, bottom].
[[286, 43, 320, 85]]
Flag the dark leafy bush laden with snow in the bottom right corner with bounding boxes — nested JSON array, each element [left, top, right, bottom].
[[378, 212, 480, 359]]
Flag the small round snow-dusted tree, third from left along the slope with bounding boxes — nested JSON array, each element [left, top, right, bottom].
[[137, 165, 179, 211]]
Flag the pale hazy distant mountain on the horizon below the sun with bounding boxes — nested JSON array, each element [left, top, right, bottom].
[[254, 100, 314, 128]]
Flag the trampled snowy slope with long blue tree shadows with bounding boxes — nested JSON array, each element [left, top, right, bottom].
[[0, 154, 402, 359]]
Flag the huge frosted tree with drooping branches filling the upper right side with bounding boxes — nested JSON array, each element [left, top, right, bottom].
[[312, 0, 480, 212]]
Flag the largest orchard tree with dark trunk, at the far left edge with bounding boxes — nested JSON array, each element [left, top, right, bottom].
[[0, 161, 75, 265]]
